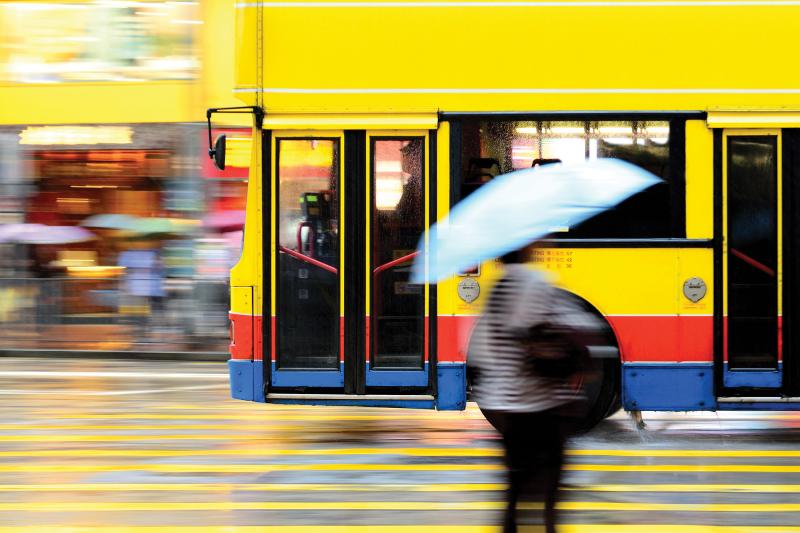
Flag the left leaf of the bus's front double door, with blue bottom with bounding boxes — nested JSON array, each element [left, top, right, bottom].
[[270, 132, 344, 389]]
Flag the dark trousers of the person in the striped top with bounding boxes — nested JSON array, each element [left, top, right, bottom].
[[481, 409, 572, 533]]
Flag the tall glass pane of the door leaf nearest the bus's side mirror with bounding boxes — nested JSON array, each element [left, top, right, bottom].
[[276, 139, 340, 369]]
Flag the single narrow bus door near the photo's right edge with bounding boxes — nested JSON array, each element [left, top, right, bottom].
[[721, 130, 784, 386]]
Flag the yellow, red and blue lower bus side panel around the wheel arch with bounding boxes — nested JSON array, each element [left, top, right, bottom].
[[450, 247, 716, 410]]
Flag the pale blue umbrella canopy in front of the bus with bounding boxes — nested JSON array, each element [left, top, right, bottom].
[[412, 159, 661, 283]]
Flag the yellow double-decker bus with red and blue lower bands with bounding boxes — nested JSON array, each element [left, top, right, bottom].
[[211, 0, 800, 419]]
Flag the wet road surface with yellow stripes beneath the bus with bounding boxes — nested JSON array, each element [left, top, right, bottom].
[[0, 358, 800, 533]]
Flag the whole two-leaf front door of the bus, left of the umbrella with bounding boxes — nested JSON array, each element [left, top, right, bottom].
[[270, 130, 430, 394]]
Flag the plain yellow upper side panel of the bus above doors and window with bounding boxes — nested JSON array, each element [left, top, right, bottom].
[[236, 1, 800, 113]]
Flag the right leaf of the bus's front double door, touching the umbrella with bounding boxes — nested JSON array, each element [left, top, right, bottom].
[[365, 132, 431, 387]]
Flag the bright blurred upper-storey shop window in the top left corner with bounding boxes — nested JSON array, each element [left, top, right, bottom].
[[0, 1, 202, 83]]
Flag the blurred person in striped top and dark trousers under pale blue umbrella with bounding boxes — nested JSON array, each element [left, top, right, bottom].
[[468, 247, 592, 533]]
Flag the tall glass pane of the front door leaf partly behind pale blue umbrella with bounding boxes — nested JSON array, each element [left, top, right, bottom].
[[370, 137, 425, 369]]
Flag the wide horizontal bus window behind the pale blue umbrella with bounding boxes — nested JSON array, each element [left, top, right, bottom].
[[459, 120, 683, 239]]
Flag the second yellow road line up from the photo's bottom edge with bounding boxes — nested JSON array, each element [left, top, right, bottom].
[[0, 501, 800, 513]]
